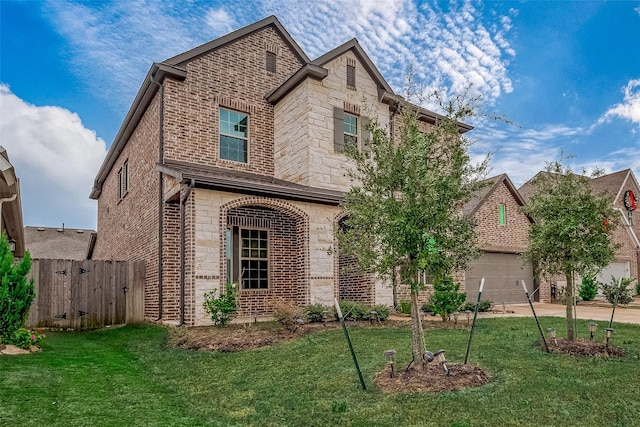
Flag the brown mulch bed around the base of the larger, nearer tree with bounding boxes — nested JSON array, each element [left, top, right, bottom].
[[374, 362, 491, 393]]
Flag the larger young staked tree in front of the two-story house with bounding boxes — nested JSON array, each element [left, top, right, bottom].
[[337, 97, 488, 369]]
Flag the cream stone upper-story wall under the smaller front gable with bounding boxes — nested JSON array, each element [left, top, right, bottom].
[[274, 51, 389, 191]]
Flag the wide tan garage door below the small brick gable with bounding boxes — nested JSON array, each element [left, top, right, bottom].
[[466, 252, 534, 305]]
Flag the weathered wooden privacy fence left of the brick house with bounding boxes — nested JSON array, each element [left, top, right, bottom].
[[27, 259, 145, 329]]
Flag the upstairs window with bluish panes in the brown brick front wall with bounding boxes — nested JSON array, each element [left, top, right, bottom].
[[220, 108, 249, 163]]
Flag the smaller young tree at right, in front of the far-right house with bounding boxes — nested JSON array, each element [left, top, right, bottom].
[[524, 161, 617, 341]]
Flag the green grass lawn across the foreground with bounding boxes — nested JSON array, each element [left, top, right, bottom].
[[0, 318, 640, 427]]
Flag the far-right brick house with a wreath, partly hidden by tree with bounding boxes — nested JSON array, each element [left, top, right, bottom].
[[518, 169, 640, 300]]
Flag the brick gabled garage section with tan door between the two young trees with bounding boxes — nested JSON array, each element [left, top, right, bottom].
[[463, 174, 539, 305]]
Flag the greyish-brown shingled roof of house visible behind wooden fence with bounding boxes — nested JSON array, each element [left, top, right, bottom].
[[24, 226, 94, 261]]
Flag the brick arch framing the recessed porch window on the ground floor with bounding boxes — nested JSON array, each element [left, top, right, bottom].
[[219, 197, 310, 316]]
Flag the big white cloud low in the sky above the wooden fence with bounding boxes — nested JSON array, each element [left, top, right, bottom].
[[0, 84, 106, 229]]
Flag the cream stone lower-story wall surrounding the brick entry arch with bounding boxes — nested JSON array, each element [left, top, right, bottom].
[[188, 189, 339, 325]]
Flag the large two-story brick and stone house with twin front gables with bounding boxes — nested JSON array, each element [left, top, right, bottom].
[[91, 16, 464, 324]]
